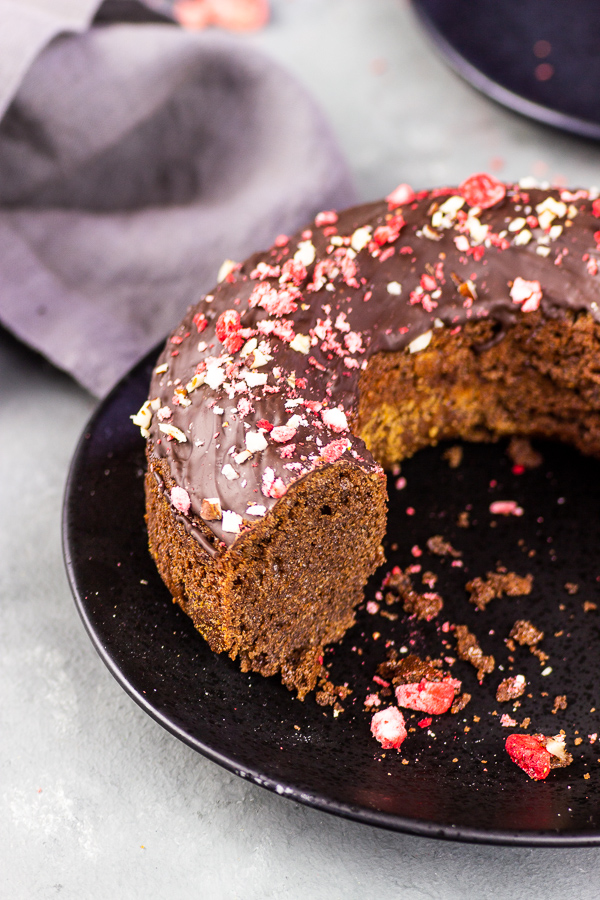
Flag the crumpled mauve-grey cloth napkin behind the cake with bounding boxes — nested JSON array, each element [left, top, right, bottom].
[[0, 0, 353, 396]]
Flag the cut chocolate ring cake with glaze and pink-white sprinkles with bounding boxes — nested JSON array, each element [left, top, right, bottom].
[[133, 175, 600, 697]]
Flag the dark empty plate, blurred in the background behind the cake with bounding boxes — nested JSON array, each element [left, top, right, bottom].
[[413, 0, 600, 139]]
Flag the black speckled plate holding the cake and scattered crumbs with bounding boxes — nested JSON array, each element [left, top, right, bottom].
[[64, 346, 600, 845]]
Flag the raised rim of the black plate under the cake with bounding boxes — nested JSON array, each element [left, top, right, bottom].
[[61, 341, 600, 848]]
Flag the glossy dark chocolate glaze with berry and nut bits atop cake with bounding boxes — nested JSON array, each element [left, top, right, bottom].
[[134, 175, 600, 540]]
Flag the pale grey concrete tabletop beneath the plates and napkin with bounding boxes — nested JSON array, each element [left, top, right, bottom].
[[0, 0, 600, 900]]
